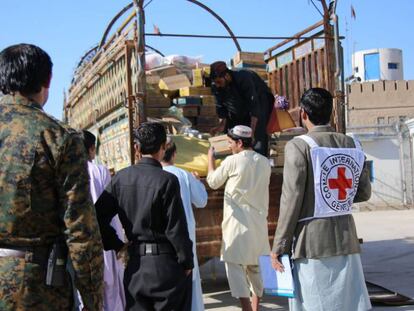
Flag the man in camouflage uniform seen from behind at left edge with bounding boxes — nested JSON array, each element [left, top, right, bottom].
[[0, 44, 103, 311]]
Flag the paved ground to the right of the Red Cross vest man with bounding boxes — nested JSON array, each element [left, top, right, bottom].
[[355, 210, 414, 300]]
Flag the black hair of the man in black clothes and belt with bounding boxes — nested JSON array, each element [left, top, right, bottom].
[[134, 122, 167, 154]]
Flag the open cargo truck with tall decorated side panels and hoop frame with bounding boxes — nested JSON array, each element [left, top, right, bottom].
[[63, 0, 345, 262]]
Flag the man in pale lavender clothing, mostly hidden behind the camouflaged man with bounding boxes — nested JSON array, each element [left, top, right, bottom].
[[80, 131, 125, 311]]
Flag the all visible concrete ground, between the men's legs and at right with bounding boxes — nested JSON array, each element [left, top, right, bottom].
[[200, 210, 414, 311]]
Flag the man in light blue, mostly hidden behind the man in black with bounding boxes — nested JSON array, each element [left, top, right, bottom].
[[161, 137, 207, 311]]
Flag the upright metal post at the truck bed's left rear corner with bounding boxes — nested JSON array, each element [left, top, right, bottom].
[[133, 0, 146, 127]]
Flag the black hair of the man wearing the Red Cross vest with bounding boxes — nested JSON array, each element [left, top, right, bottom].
[[300, 87, 333, 125]]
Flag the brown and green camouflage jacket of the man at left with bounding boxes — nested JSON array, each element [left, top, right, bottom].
[[0, 95, 103, 310]]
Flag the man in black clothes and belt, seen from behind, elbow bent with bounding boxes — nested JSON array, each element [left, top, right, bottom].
[[95, 122, 194, 311]]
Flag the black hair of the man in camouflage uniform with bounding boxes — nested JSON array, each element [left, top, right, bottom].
[[0, 43, 53, 96]]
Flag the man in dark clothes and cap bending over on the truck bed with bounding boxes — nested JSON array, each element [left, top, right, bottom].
[[210, 61, 274, 156]]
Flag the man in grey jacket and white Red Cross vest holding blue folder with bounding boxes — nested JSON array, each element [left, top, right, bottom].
[[271, 88, 371, 311]]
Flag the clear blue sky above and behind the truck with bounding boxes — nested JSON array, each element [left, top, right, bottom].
[[0, 0, 414, 118]]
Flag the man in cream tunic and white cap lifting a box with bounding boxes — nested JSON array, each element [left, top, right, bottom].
[[207, 125, 271, 311]]
